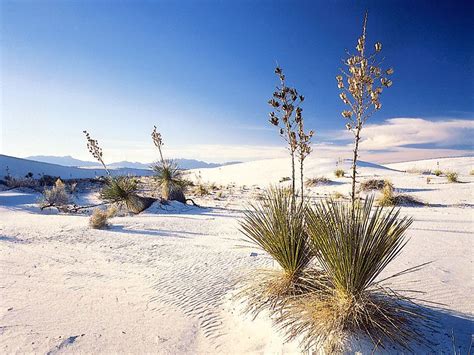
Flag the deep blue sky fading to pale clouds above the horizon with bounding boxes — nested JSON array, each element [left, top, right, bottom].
[[1, 0, 474, 161]]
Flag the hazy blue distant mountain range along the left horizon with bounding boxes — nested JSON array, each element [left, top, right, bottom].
[[25, 155, 239, 170]]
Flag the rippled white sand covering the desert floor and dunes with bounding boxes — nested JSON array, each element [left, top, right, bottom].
[[0, 158, 474, 354]]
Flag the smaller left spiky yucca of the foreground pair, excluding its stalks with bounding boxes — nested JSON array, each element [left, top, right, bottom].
[[240, 188, 311, 315]]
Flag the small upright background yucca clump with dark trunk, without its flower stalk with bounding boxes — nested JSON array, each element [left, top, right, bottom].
[[152, 160, 187, 203]]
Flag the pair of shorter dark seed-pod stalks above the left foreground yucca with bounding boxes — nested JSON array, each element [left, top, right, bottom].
[[268, 66, 314, 201]]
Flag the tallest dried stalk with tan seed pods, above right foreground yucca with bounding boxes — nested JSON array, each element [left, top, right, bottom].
[[336, 13, 393, 211]]
